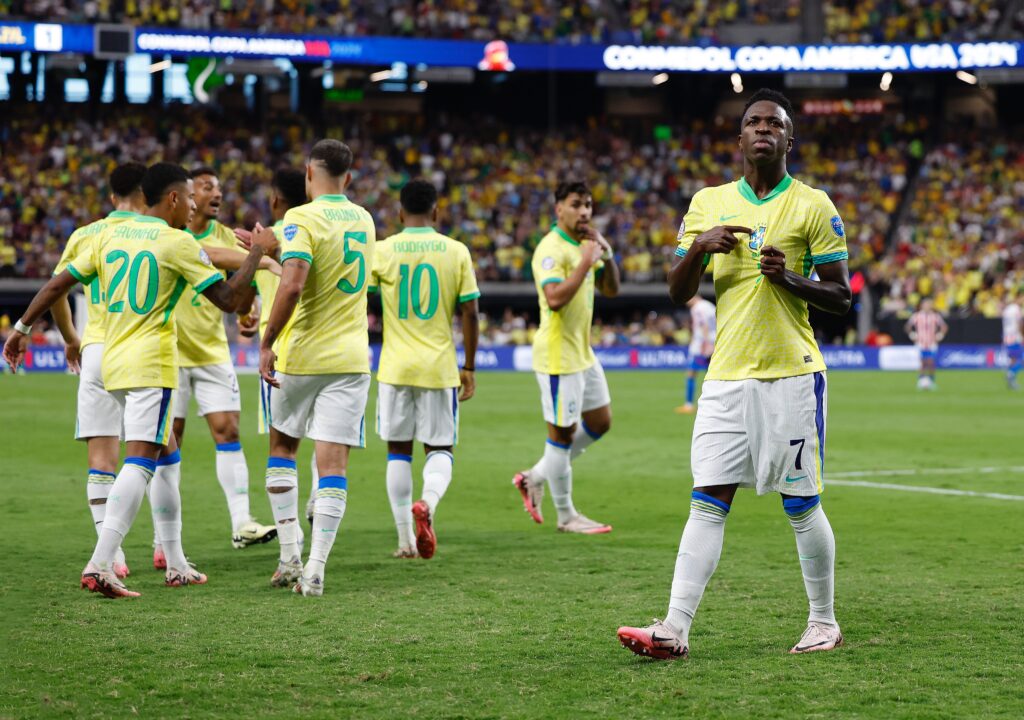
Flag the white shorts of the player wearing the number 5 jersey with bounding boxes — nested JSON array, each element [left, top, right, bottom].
[[268, 373, 370, 448]]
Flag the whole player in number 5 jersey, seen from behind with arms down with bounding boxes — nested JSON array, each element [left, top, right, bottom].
[[259, 139, 377, 595]]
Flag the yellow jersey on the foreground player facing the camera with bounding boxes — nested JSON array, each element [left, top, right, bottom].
[[676, 175, 849, 380]]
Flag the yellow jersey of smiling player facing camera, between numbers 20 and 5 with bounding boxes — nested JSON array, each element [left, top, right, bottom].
[[177, 220, 239, 368]]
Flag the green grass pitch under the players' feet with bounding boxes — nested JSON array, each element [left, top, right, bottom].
[[0, 372, 1024, 719]]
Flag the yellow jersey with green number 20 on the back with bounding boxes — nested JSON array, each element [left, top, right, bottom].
[[68, 215, 223, 390]]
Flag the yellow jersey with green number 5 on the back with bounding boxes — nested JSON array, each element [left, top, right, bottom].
[[274, 195, 377, 375]]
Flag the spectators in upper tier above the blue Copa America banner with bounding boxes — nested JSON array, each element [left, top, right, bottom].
[[0, 0, 1008, 44]]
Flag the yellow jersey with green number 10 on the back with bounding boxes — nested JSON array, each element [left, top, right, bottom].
[[370, 227, 480, 388]]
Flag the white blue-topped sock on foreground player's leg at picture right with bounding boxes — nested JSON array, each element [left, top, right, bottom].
[[782, 496, 837, 625]]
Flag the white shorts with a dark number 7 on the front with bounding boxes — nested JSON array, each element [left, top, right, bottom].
[[690, 373, 828, 497]]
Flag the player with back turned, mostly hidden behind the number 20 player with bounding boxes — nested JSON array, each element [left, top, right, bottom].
[[51, 163, 145, 580]]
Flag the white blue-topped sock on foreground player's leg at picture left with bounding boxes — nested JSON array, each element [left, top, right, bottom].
[[665, 492, 729, 644]]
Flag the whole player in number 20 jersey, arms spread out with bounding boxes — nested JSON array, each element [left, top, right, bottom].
[[4, 163, 275, 597]]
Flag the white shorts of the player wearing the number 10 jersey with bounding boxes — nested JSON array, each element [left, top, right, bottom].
[[377, 382, 459, 448]]
